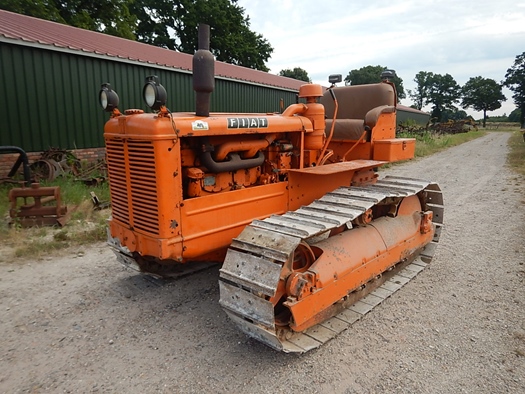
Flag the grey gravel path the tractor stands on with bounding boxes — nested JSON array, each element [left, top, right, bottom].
[[0, 133, 525, 393]]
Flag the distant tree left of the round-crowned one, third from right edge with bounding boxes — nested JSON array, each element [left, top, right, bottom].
[[425, 74, 461, 122]]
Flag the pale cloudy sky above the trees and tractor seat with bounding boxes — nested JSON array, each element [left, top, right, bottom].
[[237, 0, 525, 118]]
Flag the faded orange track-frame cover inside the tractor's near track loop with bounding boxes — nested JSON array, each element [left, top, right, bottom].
[[284, 196, 434, 331]]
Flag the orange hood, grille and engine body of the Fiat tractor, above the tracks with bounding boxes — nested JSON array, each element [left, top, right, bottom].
[[104, 81, 411, 262]]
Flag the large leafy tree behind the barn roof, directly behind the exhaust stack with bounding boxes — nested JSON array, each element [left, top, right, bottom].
[[131, 0, 273, 71]]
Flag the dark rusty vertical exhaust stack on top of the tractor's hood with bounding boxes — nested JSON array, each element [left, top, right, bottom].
[[193, 24, 215, 116]]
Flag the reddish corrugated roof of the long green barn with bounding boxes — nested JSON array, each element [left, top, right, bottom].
[[0, 10, 305, 90]]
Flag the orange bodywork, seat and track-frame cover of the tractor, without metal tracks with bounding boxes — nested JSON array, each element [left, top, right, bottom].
[[104, 84, 434, 338]]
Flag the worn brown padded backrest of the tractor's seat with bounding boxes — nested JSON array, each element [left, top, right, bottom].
[[320, 83, 395, 119]]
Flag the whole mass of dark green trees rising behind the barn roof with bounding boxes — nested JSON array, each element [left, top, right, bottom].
[[0, 0, 273, 71]]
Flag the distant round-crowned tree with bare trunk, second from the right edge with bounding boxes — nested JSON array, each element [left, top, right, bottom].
[[461, 77, 507, 127]]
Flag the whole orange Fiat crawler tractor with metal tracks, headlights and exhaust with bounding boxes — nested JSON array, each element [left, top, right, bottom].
[[100, 28, 443, 352]]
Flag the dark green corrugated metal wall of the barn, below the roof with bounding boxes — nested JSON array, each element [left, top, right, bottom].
[[0, 42, 295, 152]]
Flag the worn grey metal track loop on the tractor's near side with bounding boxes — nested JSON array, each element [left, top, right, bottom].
[[219, 176, 444, 353]]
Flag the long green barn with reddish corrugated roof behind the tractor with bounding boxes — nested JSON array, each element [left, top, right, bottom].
[[0, 10, 304, 173]]
